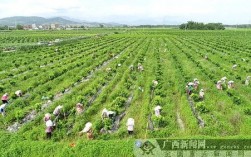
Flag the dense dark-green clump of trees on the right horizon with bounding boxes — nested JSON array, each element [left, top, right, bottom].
[[179, 21, 225, 30]]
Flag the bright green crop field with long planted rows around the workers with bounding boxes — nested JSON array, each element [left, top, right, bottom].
[[0, 29, 251, 156]]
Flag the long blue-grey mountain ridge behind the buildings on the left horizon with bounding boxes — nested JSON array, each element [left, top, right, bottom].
[[0, 16, 122, 27]]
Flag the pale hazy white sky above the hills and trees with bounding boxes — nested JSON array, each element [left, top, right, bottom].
[[0, 0, 251, 24]]
